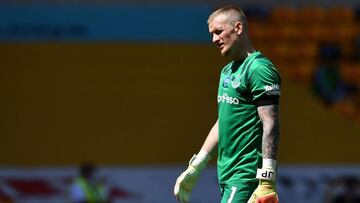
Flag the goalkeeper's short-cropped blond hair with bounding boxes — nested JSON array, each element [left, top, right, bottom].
[[207, 6, 248, 32]]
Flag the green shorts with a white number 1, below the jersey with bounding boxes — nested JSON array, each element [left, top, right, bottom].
[[220, 181, 258, 203]]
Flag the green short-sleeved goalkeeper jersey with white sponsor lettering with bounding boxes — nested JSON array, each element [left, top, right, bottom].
[[217, 52, 281, 184]]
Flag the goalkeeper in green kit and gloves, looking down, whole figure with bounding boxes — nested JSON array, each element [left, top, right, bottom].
[[174, 6, 281, 203]]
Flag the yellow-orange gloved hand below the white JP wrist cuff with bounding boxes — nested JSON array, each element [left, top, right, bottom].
[[248, 180, 279, 203]]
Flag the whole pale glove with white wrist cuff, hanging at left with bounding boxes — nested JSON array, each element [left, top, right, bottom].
[[174, 150, 211, 203]]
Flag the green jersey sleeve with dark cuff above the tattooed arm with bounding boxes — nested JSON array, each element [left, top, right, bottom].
[[250, 64, 281, 103]]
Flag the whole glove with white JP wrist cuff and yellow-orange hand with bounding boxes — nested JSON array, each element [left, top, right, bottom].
[[248, 159, 279, 203]]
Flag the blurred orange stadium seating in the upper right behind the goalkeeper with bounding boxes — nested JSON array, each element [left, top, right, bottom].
[[249, 5, 360, 120]]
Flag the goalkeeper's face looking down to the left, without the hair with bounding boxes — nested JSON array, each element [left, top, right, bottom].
[[209, 14, 238, 56]]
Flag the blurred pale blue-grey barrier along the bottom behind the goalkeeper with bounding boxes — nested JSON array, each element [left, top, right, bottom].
[[0, 165, 360, 203]]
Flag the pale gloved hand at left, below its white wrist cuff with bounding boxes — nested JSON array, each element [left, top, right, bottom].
[[174, 165, 200, 203]]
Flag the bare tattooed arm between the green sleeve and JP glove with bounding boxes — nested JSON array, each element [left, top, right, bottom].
[[257, 105, 280, 160]]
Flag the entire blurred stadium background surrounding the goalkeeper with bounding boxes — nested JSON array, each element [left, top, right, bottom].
[[0, 0, 360, 203]]
